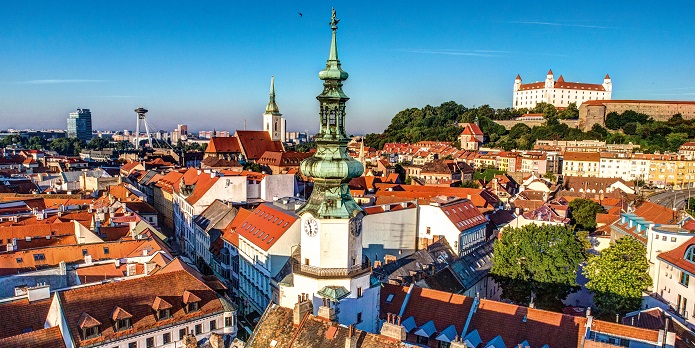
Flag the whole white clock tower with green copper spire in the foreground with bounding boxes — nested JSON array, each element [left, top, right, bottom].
[[280, 10, 380, 332]]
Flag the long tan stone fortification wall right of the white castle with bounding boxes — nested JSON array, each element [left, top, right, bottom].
[[578, 100, 695, 131]]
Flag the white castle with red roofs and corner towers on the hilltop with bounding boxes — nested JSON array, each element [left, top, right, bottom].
[[512, 70, 613, 109]]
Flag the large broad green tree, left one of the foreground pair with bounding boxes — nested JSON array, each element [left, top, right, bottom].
[[490, 224, 587, 310]]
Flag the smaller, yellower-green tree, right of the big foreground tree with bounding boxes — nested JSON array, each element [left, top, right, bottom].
[[584, 237, 652, 319]]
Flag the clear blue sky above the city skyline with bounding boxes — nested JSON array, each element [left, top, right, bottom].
[[0, 0, 695, 134]]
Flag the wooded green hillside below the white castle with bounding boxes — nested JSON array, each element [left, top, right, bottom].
[[365, 101, 695, 153]]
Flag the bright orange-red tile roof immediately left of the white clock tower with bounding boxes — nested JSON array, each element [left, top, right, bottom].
[[236, 203, 298, 251]]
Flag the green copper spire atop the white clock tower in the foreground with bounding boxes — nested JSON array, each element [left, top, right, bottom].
[[297, 9, 364, 219]]
